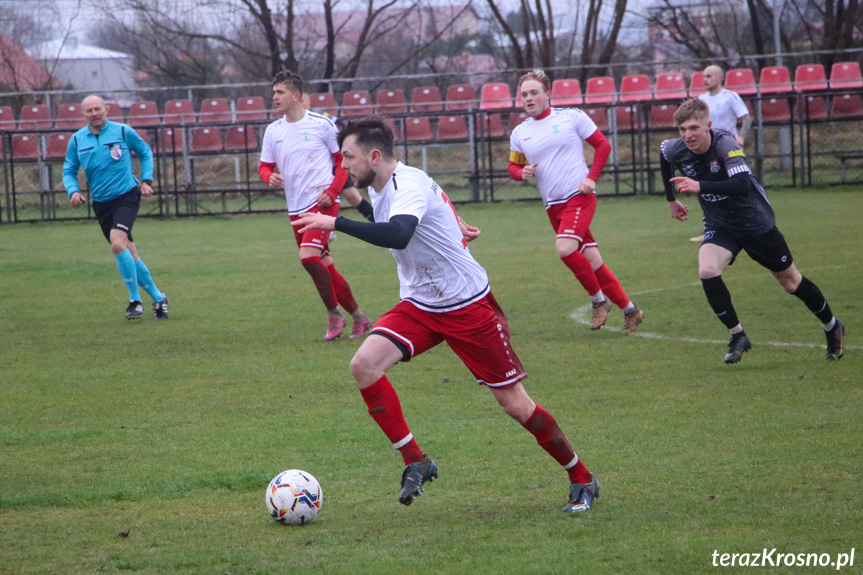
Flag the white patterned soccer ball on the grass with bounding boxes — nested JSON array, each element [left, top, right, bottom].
[[266, 469, 324, 525]]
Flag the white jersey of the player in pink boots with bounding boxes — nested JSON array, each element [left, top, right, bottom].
[[261, 112, 339, 216]]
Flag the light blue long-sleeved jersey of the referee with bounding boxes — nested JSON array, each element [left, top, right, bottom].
[[63, 120, 153, 202]]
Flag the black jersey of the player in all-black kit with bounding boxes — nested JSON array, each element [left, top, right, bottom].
[[660, 130, 776, 235]]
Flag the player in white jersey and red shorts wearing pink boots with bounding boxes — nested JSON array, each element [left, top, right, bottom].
[[258, 70, 372, 341]]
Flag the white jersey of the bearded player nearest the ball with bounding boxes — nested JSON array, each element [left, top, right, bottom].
[[369, 162, 489, 312]]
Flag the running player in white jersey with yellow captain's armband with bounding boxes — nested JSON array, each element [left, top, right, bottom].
[[509, 70, 644, 334]]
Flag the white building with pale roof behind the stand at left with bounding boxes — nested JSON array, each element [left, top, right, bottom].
[[30, 38, 135, 93]]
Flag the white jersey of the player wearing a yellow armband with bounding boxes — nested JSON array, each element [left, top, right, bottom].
[[509, 108, 596, 207]]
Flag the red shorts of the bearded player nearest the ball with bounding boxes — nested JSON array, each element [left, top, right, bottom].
[[372, 292, 527, 387]]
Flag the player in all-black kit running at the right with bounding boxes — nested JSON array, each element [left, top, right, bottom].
[[660, 99, 845, 363]]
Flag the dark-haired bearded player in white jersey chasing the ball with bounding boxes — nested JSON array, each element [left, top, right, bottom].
[[293, 116, 599, 513]]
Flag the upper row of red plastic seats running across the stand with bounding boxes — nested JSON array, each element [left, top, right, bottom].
[[5, 62, 863, 130]]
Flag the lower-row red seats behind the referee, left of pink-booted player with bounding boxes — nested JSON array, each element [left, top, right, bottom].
[[0, 125, 258, 161]]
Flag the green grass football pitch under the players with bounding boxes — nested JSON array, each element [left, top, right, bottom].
[[0, 190, 863, 575]]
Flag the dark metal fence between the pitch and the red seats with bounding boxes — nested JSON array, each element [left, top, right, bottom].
[[0, 88, 863, 223]]
